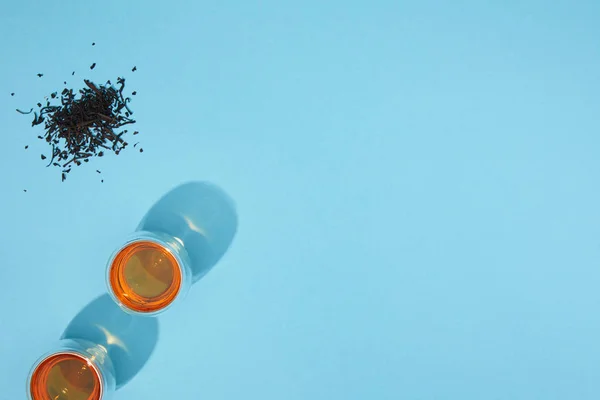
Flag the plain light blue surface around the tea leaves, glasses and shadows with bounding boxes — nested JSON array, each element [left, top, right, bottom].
[[0, 0, 600, 400]]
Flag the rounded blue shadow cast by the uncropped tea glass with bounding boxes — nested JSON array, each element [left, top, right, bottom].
[[137, 182, 238, 283]]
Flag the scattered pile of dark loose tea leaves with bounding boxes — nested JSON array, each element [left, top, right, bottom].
[[17, 42, 143, 181]]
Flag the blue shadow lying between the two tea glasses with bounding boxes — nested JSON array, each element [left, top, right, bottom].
[[61, 294, 158, 389]]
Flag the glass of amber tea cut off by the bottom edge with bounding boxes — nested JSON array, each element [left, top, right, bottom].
[[27, 339, 115, 400]]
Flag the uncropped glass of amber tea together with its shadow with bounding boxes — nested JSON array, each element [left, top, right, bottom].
[[106, 182, 237, 316]]
